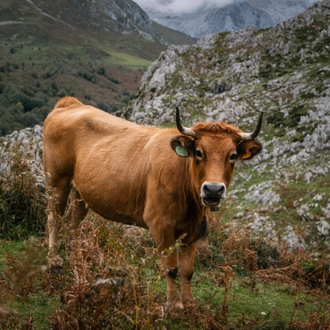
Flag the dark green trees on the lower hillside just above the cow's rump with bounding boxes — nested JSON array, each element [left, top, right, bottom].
[[0, 62, 133, 136]]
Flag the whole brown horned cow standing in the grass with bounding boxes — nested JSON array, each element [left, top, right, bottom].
[[43, 97, 262, 307]]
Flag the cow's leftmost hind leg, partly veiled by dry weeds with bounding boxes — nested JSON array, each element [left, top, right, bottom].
[[47, 177, 71, 267]]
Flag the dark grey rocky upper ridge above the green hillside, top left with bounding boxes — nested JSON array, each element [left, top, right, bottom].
[[0, 0, 192, 44]]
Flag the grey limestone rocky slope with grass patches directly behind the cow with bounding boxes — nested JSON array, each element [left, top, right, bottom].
[[0, 0, 330, 255]]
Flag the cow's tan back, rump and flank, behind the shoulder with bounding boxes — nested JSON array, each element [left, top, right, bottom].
[[43, 97, 164, 226]]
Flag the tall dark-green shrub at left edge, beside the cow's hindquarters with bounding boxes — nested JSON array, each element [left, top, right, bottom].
[[0, 144, 46, 239]]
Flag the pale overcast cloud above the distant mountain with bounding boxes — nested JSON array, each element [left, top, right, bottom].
[[133, 0, 318, 13]]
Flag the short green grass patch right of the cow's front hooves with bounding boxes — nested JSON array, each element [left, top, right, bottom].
[[155, 270, 330, 329]]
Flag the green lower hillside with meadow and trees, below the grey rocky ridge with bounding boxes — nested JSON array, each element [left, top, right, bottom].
[[0, 1, 165, 135]]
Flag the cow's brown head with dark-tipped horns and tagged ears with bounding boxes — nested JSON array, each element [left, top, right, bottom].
[[171, 108, 263, 208]]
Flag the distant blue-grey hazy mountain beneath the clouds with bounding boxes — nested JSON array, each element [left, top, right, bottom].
[[141, 0, 317, 38]]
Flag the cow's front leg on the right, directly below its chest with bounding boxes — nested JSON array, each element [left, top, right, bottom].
[[179, 241, 198, 305]]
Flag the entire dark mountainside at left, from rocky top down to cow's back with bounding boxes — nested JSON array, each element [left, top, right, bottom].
[[0, 0, 191, 135]]
